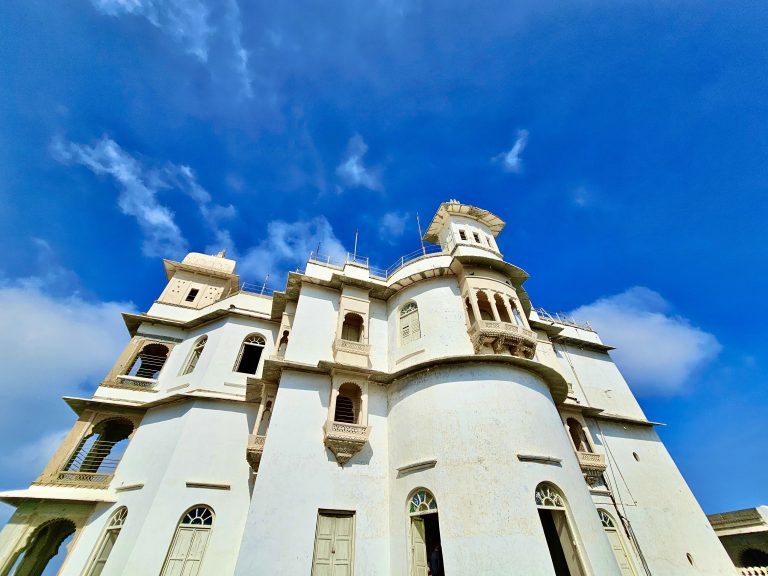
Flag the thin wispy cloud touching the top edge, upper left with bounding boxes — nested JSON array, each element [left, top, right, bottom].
[[91, 0, 253, 98]]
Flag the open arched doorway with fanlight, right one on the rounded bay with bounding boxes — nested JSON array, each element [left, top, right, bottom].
[[536, 483, 584, 576]]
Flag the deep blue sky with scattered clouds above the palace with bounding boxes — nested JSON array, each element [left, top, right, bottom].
[[0, 0, 768, 520]]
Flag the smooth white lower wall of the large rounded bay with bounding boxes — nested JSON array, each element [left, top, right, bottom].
[[388, 361, 618, 576]]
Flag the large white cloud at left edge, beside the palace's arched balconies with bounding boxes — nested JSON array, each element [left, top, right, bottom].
[[0, 278, 134, 490]]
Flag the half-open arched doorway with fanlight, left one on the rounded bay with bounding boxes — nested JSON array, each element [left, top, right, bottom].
[[408, 488, 445, 576]]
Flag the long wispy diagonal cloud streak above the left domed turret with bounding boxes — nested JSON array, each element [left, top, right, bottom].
[[51, 136, 235, 257]]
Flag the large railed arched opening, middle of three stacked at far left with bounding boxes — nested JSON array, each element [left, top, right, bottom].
[[64, 418, 133, 478]]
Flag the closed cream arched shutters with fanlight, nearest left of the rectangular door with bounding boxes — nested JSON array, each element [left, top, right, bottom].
[[160, 505, 213, 576]]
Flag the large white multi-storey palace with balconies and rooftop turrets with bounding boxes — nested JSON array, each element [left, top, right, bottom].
[[0, 200, 737, 576]]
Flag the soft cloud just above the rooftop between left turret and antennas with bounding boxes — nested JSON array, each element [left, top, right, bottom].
[[238, 216, 347, 285]]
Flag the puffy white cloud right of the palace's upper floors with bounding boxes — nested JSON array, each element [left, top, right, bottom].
[[571, 286, 721, 395]]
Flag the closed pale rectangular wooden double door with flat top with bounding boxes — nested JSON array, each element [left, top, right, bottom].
[[312, 513, 354, 576]]
